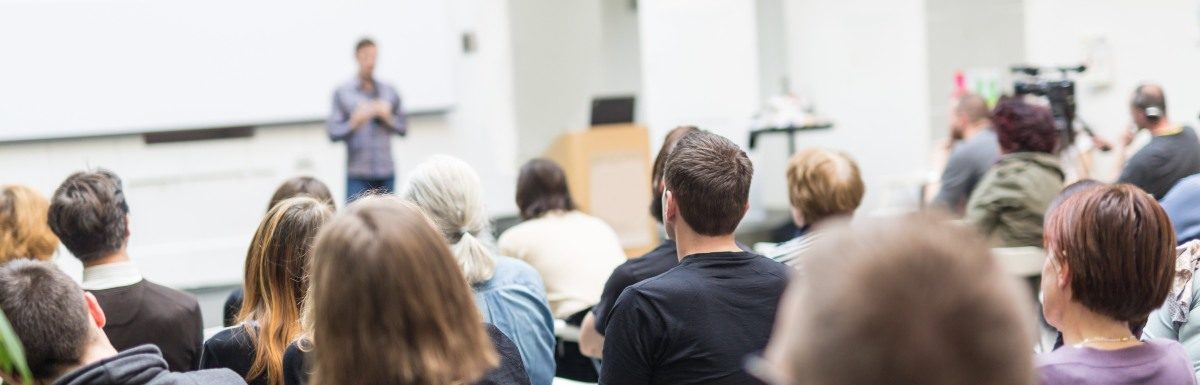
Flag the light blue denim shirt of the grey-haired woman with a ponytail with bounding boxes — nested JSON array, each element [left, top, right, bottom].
[[474, 257, 554, 385]]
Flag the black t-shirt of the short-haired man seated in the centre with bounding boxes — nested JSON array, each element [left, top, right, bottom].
[[600, 252, 791, 385]]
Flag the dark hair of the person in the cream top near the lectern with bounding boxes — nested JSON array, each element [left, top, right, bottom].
[[517, 158, 575, 219]]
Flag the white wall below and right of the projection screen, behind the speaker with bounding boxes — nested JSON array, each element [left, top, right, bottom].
[[0, 0, 517, 288]]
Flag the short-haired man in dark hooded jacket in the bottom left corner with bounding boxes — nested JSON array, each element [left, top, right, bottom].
[[0, 260, 246, 385]]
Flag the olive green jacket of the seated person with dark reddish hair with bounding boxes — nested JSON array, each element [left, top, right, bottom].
[[964, 152, 1064, 247]]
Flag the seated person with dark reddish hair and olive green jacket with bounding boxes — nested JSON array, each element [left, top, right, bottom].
[[965, 98, 1064, 247]]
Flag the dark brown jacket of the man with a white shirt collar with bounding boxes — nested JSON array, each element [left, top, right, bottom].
[[91, 279, 204, 372]]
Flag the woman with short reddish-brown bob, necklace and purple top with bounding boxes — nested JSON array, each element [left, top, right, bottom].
[[1037, 184, 1195, 385]]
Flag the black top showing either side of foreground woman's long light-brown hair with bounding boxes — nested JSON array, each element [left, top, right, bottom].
[[283, 324, 529, 385]]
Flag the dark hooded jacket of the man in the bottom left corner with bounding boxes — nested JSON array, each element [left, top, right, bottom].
[[54, 345, 246, 385]]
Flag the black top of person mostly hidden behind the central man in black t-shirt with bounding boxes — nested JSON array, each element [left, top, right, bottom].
[[592, 240, 679, 336]]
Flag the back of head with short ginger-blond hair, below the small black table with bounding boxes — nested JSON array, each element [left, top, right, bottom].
[[787, 149, 866, 224]]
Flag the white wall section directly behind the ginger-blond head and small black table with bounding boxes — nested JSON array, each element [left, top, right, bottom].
[[778, 0, 930, 211]]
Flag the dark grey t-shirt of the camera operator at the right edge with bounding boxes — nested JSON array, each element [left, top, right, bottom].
[[1117, 127, 1200, 199]]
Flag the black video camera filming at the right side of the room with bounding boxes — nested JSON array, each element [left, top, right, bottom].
[[1010, 65, 1108, 151]]
